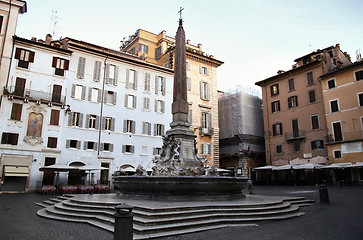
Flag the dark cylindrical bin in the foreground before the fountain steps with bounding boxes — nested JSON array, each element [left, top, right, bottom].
[[113, 203, 134, 240]]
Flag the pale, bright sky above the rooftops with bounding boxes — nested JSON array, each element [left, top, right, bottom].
[[16, 0, 363, 93]]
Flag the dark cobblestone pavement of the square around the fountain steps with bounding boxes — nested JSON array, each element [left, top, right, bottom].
[[0, 186, 363, 240]]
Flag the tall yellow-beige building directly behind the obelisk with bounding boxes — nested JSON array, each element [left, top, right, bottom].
[[121, 29, 223, 166]]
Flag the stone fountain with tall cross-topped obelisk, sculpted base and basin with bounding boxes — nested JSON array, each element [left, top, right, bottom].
[[113, 12, 248, 200]]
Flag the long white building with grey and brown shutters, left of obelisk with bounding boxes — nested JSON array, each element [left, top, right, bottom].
[[0, 35, 173, 191]]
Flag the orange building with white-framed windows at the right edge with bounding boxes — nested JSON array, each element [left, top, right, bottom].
[[320, 61, 363, 165]]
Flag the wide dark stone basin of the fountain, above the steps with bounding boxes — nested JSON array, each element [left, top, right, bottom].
[[113, 176, 248, 200]]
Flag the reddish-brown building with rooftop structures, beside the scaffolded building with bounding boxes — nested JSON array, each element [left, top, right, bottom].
[[256, 45, 351, 165]]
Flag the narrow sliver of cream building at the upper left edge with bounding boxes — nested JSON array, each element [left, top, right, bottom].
[[0, 0, 26, 89]]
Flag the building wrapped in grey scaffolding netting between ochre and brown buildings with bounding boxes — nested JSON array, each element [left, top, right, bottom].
[[218, 88, 265, 178]]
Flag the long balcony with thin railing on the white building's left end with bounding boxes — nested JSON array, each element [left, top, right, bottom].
[[4, 86, 66, 105]]
